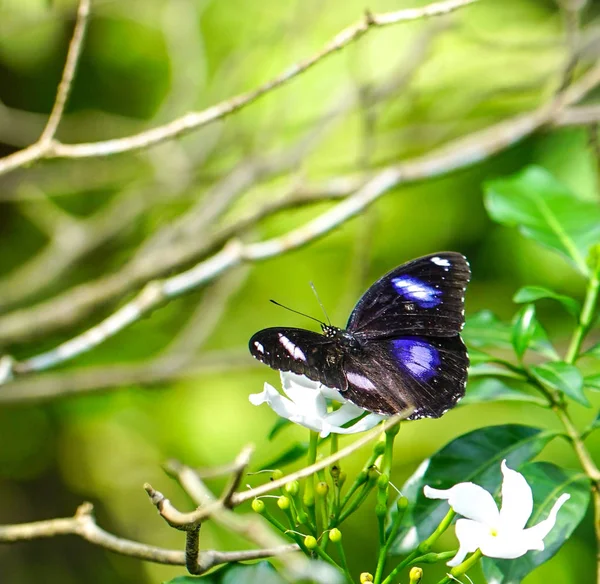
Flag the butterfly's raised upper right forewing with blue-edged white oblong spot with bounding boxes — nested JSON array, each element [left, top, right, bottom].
[[347, 252, 471, 341]]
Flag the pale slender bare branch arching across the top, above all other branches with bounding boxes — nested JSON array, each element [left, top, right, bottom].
[[0, 0, 477, 175]]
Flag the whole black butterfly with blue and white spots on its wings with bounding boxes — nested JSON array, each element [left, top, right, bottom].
[[249, 252, 471, 420]]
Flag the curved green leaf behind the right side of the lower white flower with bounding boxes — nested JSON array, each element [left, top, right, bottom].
[[483, 462, 590, 584]]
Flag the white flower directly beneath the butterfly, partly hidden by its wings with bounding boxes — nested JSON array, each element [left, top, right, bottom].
[[249, 371, 385, 438]]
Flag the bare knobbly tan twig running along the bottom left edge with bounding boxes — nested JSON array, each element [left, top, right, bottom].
[[0, 503, 298, 573]]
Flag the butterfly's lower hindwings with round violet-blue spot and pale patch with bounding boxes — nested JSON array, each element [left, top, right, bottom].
[[344, 335, 469, 420]]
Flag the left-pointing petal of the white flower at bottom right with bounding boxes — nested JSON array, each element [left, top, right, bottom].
[[423, 483, 500, 527]]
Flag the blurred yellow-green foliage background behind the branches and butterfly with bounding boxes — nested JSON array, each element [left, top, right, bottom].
[[0, 0, 600, 584]]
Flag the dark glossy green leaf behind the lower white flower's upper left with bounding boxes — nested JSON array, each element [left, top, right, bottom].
[[392, 424, 559, 551]]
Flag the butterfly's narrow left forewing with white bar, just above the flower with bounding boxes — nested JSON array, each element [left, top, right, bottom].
[[249, 327, 346, 390]]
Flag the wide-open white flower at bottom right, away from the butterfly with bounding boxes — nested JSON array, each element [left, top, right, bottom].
[[423, 460, 570, 566]]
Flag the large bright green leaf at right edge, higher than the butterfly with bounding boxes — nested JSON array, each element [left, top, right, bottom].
[[485, 166, 600, 274]]
